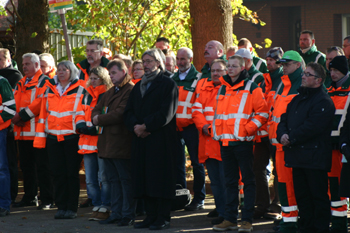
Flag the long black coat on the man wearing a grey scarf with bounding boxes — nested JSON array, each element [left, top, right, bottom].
[[124, 72, 179, 198]]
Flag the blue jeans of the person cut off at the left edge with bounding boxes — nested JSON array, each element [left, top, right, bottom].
[[0, 129, 11, 211]]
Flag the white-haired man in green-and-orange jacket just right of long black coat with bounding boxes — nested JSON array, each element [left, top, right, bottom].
[[172, 48, 205, 211]]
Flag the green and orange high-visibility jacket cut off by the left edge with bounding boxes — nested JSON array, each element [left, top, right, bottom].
[[0, 76, 16, 130]]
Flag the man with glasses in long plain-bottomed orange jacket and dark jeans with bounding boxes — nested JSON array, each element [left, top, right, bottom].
[[192, 59, 227, 225]]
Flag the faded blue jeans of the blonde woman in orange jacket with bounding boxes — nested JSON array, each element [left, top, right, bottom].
[[84, 153, 111, 206]]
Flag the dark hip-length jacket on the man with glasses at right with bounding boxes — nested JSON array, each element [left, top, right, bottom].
[[277, 86, 335, 171]]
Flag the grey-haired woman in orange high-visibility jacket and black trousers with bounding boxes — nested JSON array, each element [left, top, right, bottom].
[[34, 61, 85, 219]]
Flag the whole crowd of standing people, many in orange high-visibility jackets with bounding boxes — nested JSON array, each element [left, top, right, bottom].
[[0, 30, 350, 233]]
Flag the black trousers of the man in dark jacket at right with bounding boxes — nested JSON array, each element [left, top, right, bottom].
[[293, 168, 331, 233]]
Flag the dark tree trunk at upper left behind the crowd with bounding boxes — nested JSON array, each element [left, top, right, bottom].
[[15, 0, 49, 71]]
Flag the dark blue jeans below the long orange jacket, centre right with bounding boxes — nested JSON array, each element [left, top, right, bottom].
[[205, 159, 226, 217]]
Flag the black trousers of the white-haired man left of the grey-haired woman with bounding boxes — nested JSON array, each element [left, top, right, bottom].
[[18, 140, 53, 204]]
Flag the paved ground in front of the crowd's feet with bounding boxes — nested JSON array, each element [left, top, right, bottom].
[[0, 190, 273, 233]]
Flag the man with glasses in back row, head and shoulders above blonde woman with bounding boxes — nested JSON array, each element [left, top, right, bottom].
[[77, 40, 109, 86]]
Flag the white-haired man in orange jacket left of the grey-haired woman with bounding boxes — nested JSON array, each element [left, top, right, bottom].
[[12, 53, 53, 209]]
